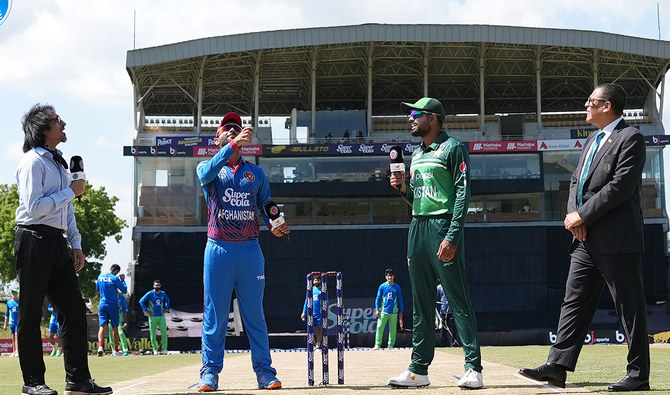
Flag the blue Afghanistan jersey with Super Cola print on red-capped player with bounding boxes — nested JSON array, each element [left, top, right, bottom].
[[196, 141, 272, 241]]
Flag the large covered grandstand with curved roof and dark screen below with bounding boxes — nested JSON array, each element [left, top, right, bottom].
[[124, 24, 670, 348]]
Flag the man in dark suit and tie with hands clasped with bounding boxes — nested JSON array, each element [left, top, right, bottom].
[[520, 84, 649, 391]]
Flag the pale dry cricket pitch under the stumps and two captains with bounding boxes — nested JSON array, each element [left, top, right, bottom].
[[113, 349, 589, 395]]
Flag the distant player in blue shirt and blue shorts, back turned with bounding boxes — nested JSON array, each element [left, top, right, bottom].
[[95, 263, 128, 357]]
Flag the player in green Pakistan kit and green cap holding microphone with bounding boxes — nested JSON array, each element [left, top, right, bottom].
[[389, 97, 484, 389]]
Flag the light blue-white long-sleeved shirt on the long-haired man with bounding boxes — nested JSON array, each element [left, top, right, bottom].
[[15, 147, 81, 249]]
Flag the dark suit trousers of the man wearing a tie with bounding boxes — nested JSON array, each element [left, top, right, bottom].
[[547, 243, 649, 380]]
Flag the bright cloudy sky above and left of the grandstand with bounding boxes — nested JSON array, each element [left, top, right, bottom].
[[0, 0, 670, 282]]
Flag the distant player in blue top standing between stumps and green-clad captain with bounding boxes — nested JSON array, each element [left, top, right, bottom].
[[374, 269, 404, 350]]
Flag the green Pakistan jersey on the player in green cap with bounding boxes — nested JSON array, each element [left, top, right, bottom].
[[405, 131, 470, 242]]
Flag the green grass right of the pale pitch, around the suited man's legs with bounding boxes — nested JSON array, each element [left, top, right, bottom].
[[438, 345, 670, 394]]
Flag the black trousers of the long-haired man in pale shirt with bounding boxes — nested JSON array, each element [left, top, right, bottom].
[[14, 225, 91, 386]]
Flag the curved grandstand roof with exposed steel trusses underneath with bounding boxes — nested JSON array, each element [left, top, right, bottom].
[[126, 24, 670, 116]]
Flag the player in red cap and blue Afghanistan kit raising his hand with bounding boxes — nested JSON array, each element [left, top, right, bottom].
[[196, 112, 289, 391]]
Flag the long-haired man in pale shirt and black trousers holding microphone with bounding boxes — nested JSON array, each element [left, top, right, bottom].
[[14, 104, 112, 395]]
